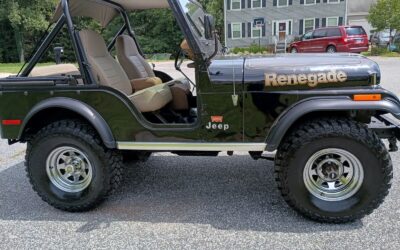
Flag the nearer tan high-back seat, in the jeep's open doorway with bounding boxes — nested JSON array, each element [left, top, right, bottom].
[[79, 30, 172, 112]]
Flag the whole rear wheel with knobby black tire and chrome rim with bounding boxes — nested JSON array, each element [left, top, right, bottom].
[[25, 120, 123, 212]]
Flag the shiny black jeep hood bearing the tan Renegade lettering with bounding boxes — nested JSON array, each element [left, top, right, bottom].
[[209, 54, 380, 90]]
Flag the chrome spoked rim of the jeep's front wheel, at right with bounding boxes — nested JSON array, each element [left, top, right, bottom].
[[303, 148, 364, 201]]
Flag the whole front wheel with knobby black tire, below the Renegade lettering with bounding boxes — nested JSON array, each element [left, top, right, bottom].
[[275, 118, 393, 223]]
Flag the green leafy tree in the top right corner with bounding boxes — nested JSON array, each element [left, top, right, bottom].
[[368, 0, 400, 40]]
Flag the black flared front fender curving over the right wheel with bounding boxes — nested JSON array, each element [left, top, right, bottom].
[[266, 97, 400, 152]]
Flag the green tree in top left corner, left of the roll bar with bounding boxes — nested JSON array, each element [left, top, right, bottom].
[[0, 0, 56, 62]]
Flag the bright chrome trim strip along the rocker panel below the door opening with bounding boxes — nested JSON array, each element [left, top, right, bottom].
[[117, 142, 267, 152]]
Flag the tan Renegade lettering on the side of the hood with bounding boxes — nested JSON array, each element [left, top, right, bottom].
[[265, 70, 347, 88]]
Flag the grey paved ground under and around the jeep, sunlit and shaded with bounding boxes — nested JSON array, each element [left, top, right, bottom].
[[0, 58, 400, 249]]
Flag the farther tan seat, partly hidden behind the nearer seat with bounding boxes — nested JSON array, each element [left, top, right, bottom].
[[115, 35, 190, 110]]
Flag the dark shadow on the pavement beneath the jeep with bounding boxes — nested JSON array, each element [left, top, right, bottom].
[[0, 156, 363, 233]]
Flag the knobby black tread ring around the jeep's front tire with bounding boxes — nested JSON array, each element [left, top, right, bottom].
[[275, 118, 393, 223]]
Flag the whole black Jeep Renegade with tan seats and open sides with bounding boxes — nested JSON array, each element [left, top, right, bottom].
[[0, 0, 400, 223]]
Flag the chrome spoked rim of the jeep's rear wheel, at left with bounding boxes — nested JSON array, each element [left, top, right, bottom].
[[46, 147, 93, 193]]
